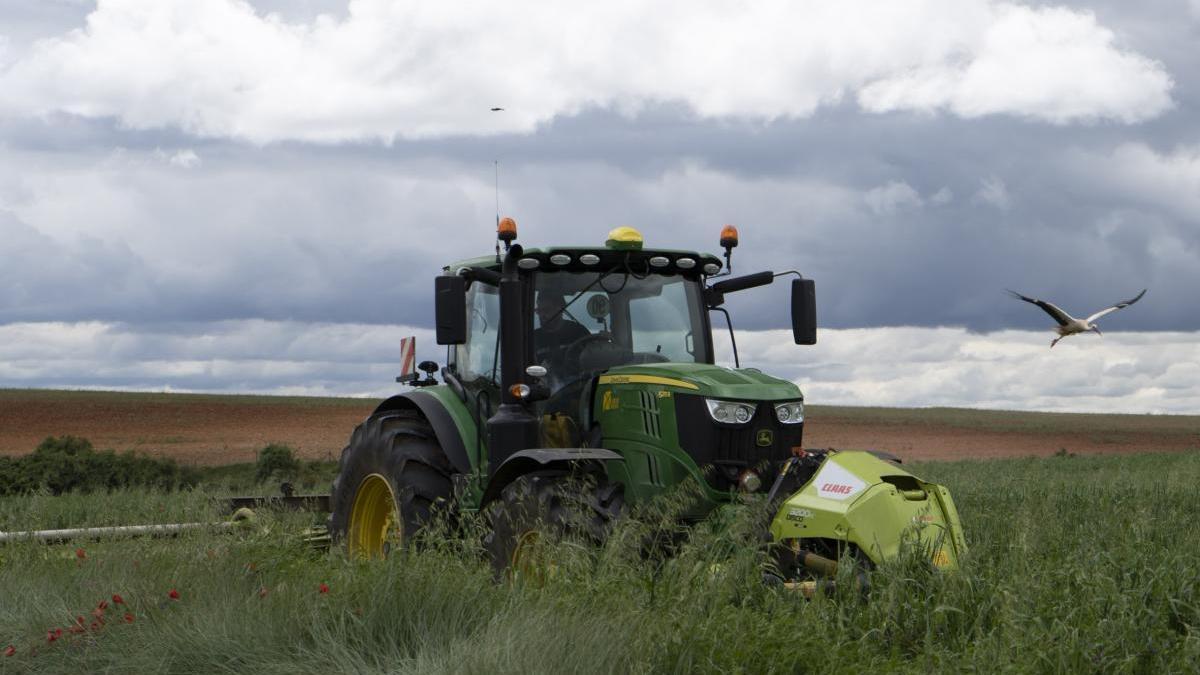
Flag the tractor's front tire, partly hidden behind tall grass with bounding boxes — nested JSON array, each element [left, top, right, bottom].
[[484, 471, 625, 580]]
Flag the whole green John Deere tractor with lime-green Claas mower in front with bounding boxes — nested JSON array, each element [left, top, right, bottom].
[[330, 219, 965, 589]]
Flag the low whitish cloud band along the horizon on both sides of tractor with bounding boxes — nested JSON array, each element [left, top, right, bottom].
[[0, 321, 1200, 414]]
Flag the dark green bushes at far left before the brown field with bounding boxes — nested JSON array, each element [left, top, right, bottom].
[[0, 436, 199, 495]]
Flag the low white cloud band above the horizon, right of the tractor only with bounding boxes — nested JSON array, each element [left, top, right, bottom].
[[714, 328, 1200, 414]]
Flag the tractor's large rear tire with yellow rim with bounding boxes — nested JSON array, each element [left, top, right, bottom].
[[329, 410, 454, 558]]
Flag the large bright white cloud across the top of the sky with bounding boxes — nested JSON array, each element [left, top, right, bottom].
[[0, 0, 1172, 143]]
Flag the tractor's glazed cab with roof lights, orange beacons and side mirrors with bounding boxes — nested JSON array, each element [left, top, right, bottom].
[[438, 221, 815, 468]]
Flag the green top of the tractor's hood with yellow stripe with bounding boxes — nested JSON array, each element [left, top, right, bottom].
[[600, 363, 804, 401]]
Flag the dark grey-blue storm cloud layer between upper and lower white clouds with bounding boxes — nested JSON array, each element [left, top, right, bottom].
[[0, 2, 1200, 330]]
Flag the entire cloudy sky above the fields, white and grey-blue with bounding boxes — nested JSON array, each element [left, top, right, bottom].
[[0, 0, 1200, 413]]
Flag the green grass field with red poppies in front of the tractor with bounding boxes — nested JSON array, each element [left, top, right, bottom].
[[0, 453, 1200, 673]]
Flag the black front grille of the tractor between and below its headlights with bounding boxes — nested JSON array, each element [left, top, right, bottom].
[[674, 394, 804, 490]]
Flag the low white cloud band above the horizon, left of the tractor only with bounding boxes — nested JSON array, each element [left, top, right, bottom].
[[0, 321, 445, 396]]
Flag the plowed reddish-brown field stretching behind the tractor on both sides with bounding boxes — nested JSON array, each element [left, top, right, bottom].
[[0, 389, 1200, 465]]
